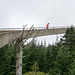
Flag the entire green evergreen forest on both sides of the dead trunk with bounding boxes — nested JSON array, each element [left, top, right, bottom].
[[0, 27, 75, 75]]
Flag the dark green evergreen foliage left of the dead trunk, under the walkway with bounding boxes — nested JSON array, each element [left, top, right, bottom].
[[0, 44, 16, 75]]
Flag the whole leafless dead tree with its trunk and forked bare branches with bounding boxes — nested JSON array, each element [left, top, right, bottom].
[[16, 26, 37, 75]]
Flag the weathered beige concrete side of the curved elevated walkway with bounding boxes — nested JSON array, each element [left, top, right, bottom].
[[0, 28, 74, 48]]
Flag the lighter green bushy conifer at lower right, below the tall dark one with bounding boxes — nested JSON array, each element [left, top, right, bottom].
[[55, 49, 72, 75]]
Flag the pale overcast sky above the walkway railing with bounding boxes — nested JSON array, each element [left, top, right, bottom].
[[0, 0, 75, 44]]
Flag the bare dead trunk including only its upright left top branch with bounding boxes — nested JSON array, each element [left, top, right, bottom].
[[16, 26, 25, 75]]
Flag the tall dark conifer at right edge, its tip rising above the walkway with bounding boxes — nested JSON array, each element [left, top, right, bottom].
[[62, 26, 75, 51]]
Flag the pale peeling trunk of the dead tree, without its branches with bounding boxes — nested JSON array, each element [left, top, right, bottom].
[[16, 40, 22, 75]]
